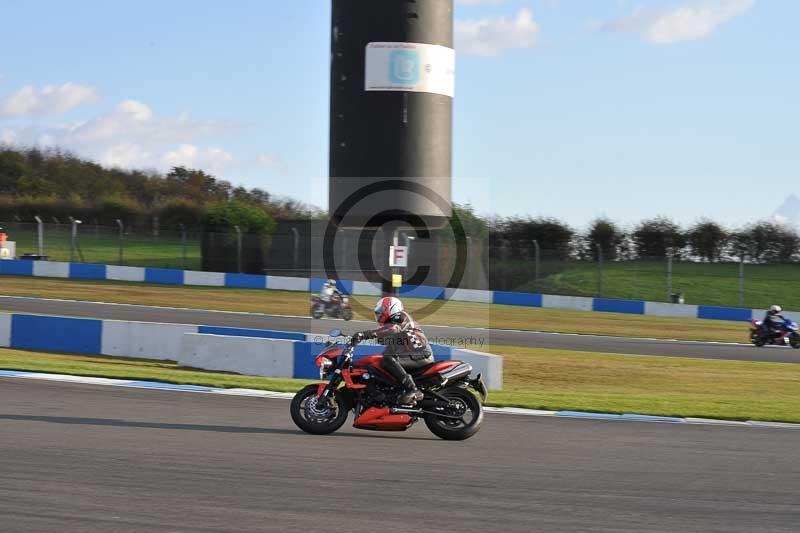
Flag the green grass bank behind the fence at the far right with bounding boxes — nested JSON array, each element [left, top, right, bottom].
[[523, 261, 800, 310]]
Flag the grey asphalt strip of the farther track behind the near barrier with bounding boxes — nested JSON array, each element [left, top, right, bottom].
[[0, 296, 800, 363]]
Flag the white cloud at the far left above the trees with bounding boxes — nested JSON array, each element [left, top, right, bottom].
[[0, 82, 100, 118]]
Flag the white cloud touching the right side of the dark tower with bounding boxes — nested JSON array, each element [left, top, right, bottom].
[[455, 8, 539, 56]]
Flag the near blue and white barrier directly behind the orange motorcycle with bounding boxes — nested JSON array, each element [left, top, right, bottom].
[[0, 314, 503, 389]]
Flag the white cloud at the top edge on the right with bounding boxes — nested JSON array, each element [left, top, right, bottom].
[[596, 0, 755, 44]]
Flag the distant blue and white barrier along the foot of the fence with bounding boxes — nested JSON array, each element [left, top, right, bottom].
[[0, 260, 800, 320]]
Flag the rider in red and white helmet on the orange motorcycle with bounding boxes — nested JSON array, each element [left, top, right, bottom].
[[352, 296, 433, 405]]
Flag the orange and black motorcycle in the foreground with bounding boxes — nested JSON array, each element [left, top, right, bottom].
[[290, 330, 487, 440]]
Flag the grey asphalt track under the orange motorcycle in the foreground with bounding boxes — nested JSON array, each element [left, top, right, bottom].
[[0, 378, 800, 533]]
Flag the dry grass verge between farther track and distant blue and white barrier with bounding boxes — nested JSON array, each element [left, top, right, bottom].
[[0, 276, 748, 342]]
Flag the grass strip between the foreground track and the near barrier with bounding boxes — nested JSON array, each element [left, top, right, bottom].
[[0, 346, 800, 422]]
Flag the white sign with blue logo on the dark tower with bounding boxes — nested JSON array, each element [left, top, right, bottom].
[[364, 43, 456, 98]]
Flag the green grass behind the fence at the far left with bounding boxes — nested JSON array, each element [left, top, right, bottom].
[[8, 224, 201, 270]]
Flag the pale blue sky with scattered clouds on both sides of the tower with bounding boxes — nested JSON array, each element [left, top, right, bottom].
[[0, 0, 800, 227]]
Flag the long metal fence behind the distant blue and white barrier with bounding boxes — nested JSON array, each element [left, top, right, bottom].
[[0, 221, 800, 309]]
